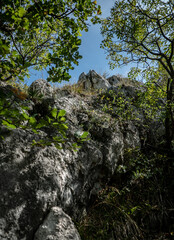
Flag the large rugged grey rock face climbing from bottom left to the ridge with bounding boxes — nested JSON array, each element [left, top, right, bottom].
[[0, 71, 162, 240]]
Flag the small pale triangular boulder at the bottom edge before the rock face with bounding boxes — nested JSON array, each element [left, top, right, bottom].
[[34, 207, 80, 240]]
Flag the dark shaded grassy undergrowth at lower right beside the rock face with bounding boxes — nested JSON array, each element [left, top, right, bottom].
[[78, 149, 174, 240]]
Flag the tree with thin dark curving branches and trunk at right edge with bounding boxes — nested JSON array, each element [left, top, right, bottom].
[[102, 0, 174, 149]]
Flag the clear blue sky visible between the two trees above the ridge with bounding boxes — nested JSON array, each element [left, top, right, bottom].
[[26, 0, 130, 84]]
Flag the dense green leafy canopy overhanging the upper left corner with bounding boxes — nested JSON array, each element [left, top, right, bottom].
[[0, 0, 100, 82]]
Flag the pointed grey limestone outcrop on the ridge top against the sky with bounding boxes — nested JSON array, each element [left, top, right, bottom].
[[78, 70, 111, 90]]
